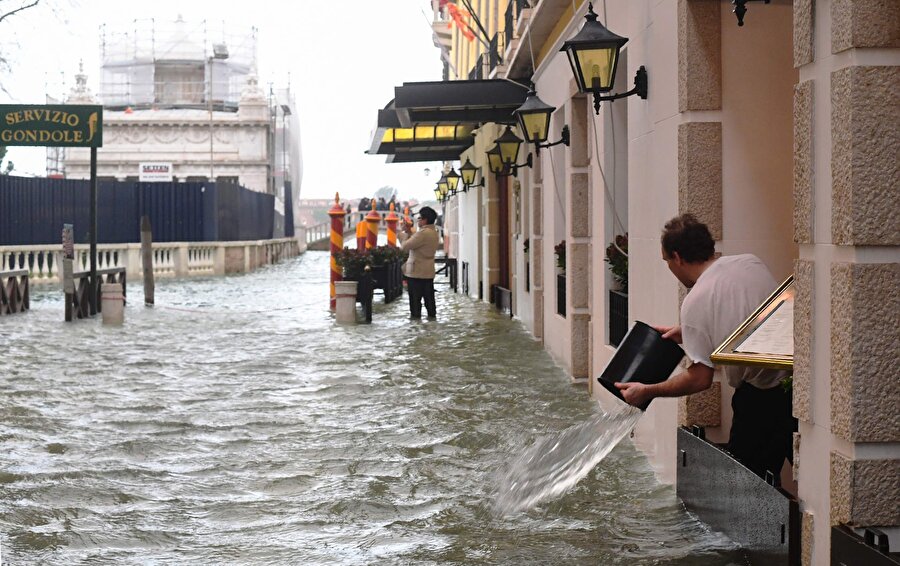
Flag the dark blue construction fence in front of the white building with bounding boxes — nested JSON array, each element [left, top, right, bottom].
[[0, 175, 282, 246]]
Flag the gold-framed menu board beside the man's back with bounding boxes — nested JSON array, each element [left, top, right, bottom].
[[709, 275, 794, 370]]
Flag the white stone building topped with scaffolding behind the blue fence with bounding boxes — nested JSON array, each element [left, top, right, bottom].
[[63, 17, 302, 235]]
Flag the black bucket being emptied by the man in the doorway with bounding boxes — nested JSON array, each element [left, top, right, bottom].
[[597, 321, 684, 411]]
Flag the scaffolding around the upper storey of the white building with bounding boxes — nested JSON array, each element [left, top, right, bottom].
[[99, 17, 257, 111]]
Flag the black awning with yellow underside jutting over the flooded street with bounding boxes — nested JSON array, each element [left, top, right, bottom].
[[367, 80, 528, 163]]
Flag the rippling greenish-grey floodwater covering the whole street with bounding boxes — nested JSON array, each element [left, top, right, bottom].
[[0, 252, 743, 566]]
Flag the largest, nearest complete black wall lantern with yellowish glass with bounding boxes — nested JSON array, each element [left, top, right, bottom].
[[560, 2, 647, 114]]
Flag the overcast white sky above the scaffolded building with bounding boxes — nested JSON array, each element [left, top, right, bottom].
[[0, 0, 441, 200]]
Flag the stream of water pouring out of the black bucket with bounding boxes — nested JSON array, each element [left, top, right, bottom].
[[494, 403, 643, 515]]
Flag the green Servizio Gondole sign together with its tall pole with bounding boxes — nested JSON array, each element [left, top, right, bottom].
[[0, 104, 103, 315]]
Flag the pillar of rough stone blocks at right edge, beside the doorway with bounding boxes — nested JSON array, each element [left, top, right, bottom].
[[793, 0, 900, 564]]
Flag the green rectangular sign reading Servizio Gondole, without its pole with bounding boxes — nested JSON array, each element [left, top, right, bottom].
[[0, 104, 103, 147]]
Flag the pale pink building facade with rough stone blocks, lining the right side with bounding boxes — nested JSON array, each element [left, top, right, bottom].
[[370, 0, 900, 564]]
